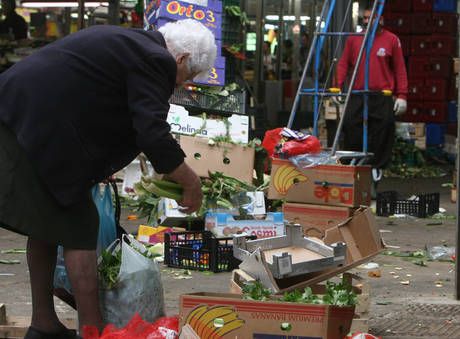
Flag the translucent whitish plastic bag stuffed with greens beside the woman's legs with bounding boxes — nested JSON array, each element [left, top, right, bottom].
[[99, 235, 164, 327]]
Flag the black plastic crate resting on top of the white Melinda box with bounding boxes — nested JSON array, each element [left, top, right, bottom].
[[170, 88, 246, 115]]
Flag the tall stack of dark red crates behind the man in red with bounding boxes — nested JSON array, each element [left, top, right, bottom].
[[384, 0, 458, 151]]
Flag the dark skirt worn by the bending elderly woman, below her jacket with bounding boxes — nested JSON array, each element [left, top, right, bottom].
[[0, 122, 99, 250]]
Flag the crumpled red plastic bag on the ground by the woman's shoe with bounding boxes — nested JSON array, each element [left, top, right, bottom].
[[83, 314, 179, 339]]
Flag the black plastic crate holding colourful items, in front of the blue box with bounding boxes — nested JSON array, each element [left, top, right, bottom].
[[164, 231, 254, 273]]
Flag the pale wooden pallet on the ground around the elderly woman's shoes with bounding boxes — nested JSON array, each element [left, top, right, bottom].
[[0, 304, 77, 339]]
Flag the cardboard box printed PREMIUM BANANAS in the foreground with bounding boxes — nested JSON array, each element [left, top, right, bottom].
[[179, 293, 355, 339]]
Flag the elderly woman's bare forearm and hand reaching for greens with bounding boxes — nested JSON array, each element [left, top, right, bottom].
[[166, 162, 203, 214]]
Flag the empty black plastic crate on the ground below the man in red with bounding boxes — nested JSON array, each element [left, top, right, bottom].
[[377, 191, 439, 218]]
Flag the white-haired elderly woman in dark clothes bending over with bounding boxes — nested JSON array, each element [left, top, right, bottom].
[[0, 19, 216, 339]]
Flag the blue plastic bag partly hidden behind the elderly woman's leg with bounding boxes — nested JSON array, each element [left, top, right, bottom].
[[54, 184, 117, 292]]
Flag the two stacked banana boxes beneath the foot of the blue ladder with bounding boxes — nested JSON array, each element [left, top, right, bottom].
[[268, 159, 371, 236]]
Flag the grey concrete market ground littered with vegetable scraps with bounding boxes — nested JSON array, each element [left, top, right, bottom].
[[0, 176, 460, 338]]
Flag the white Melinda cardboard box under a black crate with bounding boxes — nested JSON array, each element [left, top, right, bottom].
[[167, 105, 249, 144]]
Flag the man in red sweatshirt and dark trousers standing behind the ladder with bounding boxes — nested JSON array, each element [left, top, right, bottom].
[[337, 9, 407, 191]]
